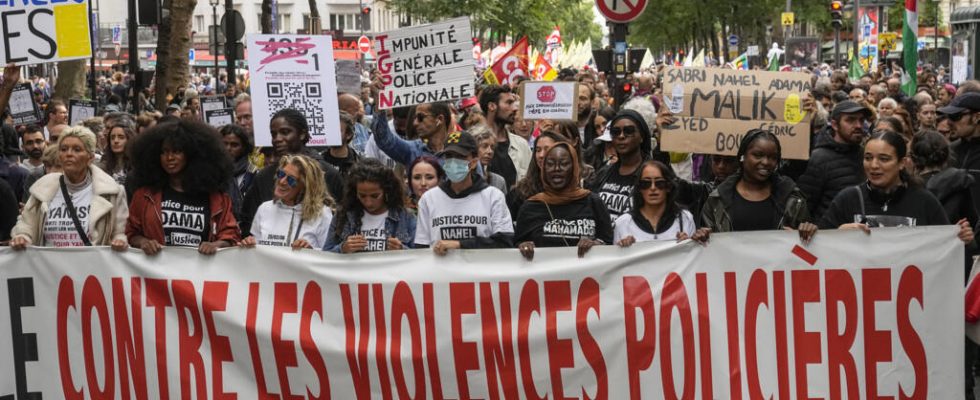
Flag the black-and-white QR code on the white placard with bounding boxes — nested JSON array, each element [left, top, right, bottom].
[[266, 82, 326, 138]]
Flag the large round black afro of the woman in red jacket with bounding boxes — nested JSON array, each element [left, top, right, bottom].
[[130, 120, 232, 194]]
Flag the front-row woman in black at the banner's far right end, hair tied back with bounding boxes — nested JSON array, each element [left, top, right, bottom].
[[820, 131, 974, 244]]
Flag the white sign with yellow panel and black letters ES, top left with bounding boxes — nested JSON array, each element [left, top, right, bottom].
[[0, 0, 92, 65]]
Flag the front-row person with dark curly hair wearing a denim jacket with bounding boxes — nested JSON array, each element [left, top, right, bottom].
[[323, 159, 412, 253]]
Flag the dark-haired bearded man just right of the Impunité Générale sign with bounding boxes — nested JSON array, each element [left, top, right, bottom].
[[480, 85, 531, 188]]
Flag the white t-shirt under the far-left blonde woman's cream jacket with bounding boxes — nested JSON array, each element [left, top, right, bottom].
[[43, 185, 92, 247]]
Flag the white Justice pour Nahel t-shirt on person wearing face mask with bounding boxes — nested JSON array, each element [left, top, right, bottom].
[[415, 187, 514, 246]]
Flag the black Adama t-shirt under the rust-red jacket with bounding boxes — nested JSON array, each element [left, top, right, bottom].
[[160, 187, 211, 247]]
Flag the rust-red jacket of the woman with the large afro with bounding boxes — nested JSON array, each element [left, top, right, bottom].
[[126, 187, 241, 245]]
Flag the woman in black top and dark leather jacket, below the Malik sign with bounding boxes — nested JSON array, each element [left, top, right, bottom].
[[701, 129, 817, 242]]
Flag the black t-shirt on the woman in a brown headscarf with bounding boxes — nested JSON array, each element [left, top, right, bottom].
[[514, 194, 613, 247]]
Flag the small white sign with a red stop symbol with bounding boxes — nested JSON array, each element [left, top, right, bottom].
[[521, 81, 578, 121]]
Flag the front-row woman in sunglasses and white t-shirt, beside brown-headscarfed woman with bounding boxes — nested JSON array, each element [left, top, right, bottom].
[[613, 160, 709, 247]]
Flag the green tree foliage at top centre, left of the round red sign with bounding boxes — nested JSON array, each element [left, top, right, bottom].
[[379, 0, 602, 46]]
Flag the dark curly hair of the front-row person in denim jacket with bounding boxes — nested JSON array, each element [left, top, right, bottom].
[[332, 158, 405, 242]]
